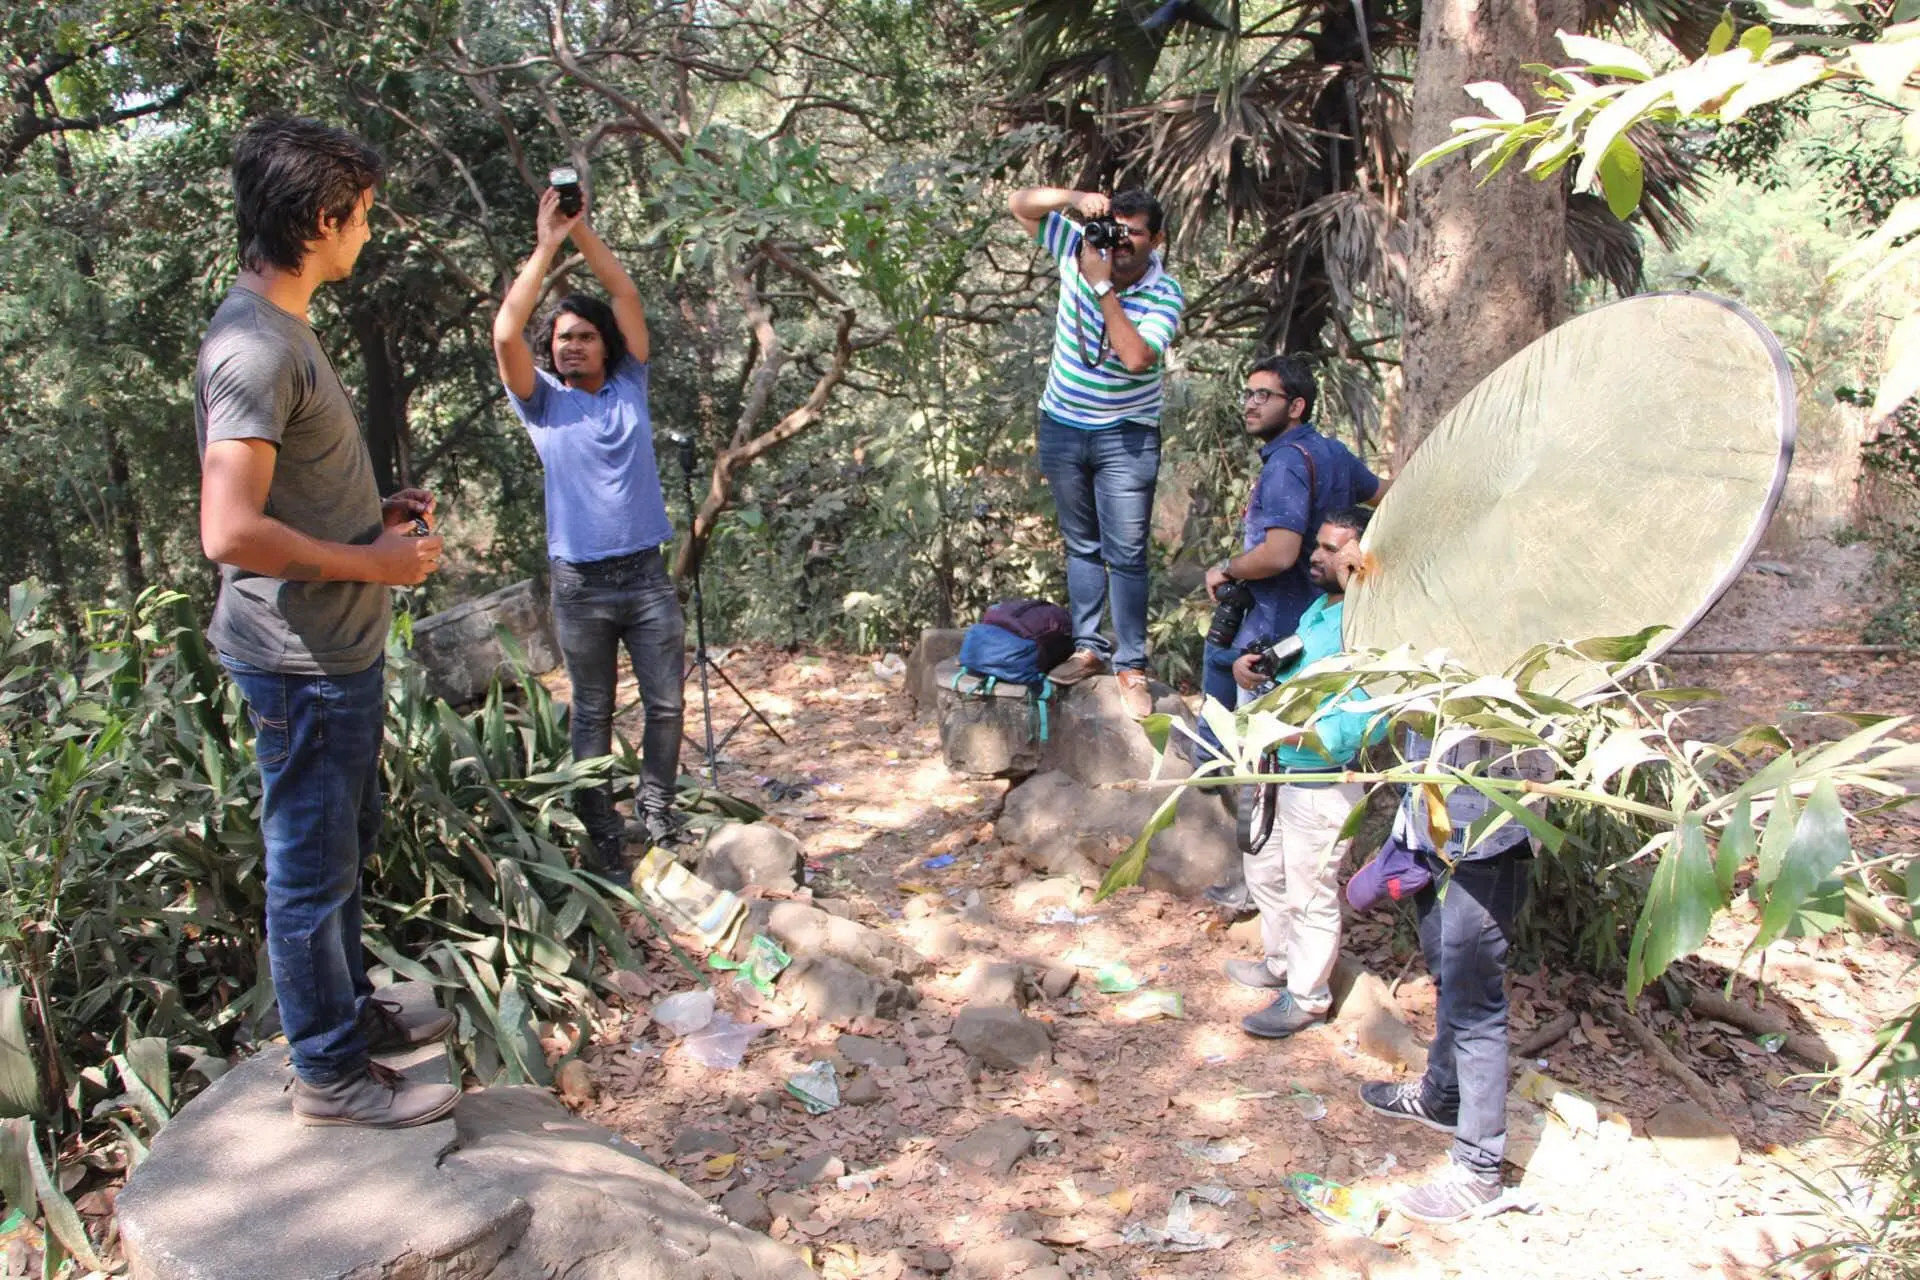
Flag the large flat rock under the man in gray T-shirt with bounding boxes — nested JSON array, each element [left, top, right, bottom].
[[115, 984, 808, 1280]]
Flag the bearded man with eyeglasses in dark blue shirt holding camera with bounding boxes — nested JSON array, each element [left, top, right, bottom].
[[1200, 355, 1388, 921]]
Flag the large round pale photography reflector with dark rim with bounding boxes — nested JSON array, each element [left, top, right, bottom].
[[1344, 294, 1795, 697]]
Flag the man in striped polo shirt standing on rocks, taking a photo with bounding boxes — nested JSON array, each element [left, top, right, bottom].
[[1008, 186, 1187, 720]]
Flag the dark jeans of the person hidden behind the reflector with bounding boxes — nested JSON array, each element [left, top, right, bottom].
[[1413, 844, 1530, 1178]]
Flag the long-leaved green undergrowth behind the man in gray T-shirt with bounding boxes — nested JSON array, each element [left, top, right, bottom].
[[0, 583, 668, 1261]]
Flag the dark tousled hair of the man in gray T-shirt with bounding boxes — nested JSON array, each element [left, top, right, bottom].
[[234, 117, 386, 271]]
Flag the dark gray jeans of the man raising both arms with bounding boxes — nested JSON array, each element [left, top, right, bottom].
[[551, 549, 687, 844]]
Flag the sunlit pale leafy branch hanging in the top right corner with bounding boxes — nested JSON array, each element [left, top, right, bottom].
[[1415, 0, 1920, 416]]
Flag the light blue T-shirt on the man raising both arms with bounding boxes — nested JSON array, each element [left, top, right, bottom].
[[507, 355, 674, 562]]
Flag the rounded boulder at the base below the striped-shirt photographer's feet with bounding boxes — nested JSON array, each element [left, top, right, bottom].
[[995, 771, 1240, 898]]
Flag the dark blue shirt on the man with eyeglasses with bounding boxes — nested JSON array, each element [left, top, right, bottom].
[[1235, 422, 1380, 649]]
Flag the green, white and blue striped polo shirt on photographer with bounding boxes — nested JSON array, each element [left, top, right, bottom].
[[1039, 213, 1187, 430]]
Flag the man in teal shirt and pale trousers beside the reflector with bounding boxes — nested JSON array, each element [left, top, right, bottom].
[[1227, 507, 1384, 1038]]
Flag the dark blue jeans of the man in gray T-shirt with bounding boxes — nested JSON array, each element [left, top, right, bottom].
[[221, 654, 386, 1084]]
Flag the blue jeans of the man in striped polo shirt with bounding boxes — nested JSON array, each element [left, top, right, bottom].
[[1041, 413, 1160, 670]]
